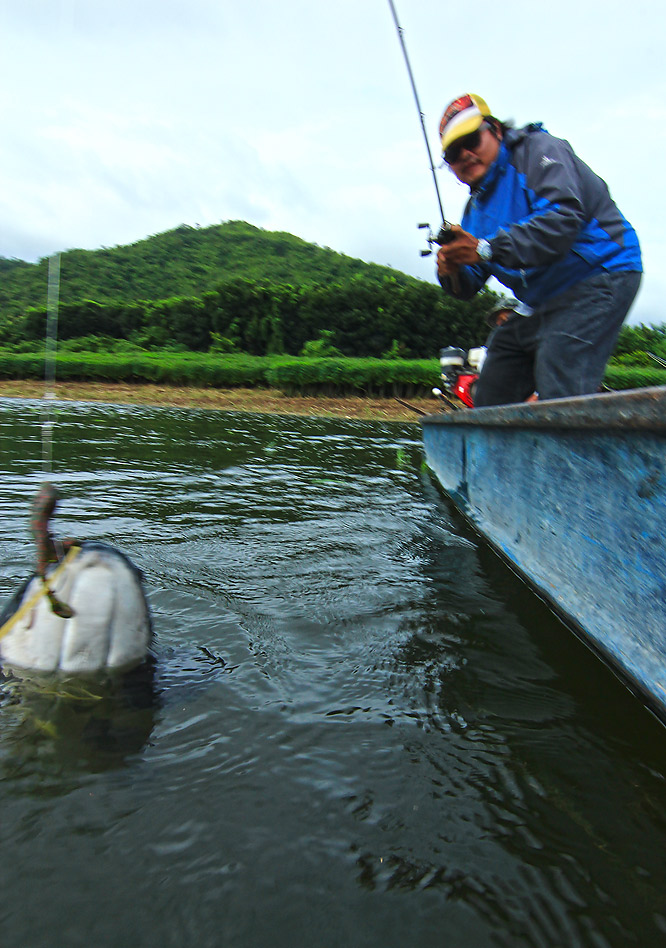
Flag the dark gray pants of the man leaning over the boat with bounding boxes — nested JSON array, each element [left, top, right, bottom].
[[474, 271, 641, 408]]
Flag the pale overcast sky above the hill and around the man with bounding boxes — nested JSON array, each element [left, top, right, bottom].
[[0, 0, 666, 324]]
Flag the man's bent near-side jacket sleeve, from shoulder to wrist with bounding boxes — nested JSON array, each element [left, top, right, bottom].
[[489, 132, 588, 269]]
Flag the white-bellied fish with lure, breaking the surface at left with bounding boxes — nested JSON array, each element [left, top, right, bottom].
[[0, 484, 152, 674]]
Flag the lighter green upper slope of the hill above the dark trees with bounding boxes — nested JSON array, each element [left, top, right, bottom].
[[0, 221, 419, 317]]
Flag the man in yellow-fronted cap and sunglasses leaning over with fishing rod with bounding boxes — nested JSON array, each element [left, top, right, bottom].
[[437, 95, 643, 407]]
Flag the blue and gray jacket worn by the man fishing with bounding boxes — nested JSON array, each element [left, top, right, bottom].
[[441, 123, 643, 307]]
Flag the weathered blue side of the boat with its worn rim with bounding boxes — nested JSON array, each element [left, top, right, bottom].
[[422, 387, 666, 718]]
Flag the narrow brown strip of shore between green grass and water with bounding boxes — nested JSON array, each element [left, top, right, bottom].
[[0, 379, 438, 422]]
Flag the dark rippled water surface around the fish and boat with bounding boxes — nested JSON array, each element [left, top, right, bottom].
[[0, 400, 666, 948]]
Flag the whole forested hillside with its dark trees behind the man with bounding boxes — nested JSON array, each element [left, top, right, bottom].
[[0, 221, 666, 390]]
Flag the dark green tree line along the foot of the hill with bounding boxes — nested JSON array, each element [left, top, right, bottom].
[[0, 276, 494, 358]]
